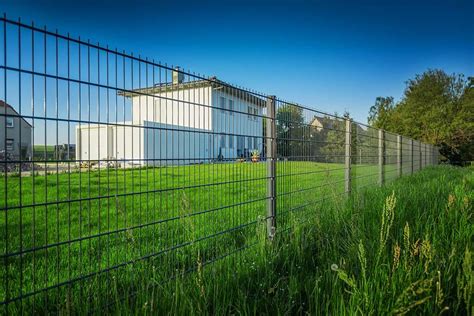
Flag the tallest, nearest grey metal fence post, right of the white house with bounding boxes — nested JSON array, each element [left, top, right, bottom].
[[265, 96, 277, 239]]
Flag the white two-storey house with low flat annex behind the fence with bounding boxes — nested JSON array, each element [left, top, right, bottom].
[[76, 67, 266, 165]]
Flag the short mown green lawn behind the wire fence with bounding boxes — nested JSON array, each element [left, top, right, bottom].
[[0, 162, 416, 312]]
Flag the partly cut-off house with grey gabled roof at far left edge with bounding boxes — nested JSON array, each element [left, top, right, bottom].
[[0, 100, 33, 160]]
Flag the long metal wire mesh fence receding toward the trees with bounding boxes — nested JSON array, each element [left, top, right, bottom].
[[0, 16, 437, 314]]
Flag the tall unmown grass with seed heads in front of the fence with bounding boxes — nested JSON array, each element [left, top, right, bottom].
[[108, 166, 474, 315]]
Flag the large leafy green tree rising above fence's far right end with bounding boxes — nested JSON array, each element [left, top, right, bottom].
[[369, 70, 474, 164]]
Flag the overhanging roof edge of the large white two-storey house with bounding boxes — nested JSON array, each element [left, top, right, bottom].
[[118, 77, 266, 107]]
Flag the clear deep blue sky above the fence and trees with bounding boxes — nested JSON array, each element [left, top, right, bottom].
[[0, 0, 474, 122]]
